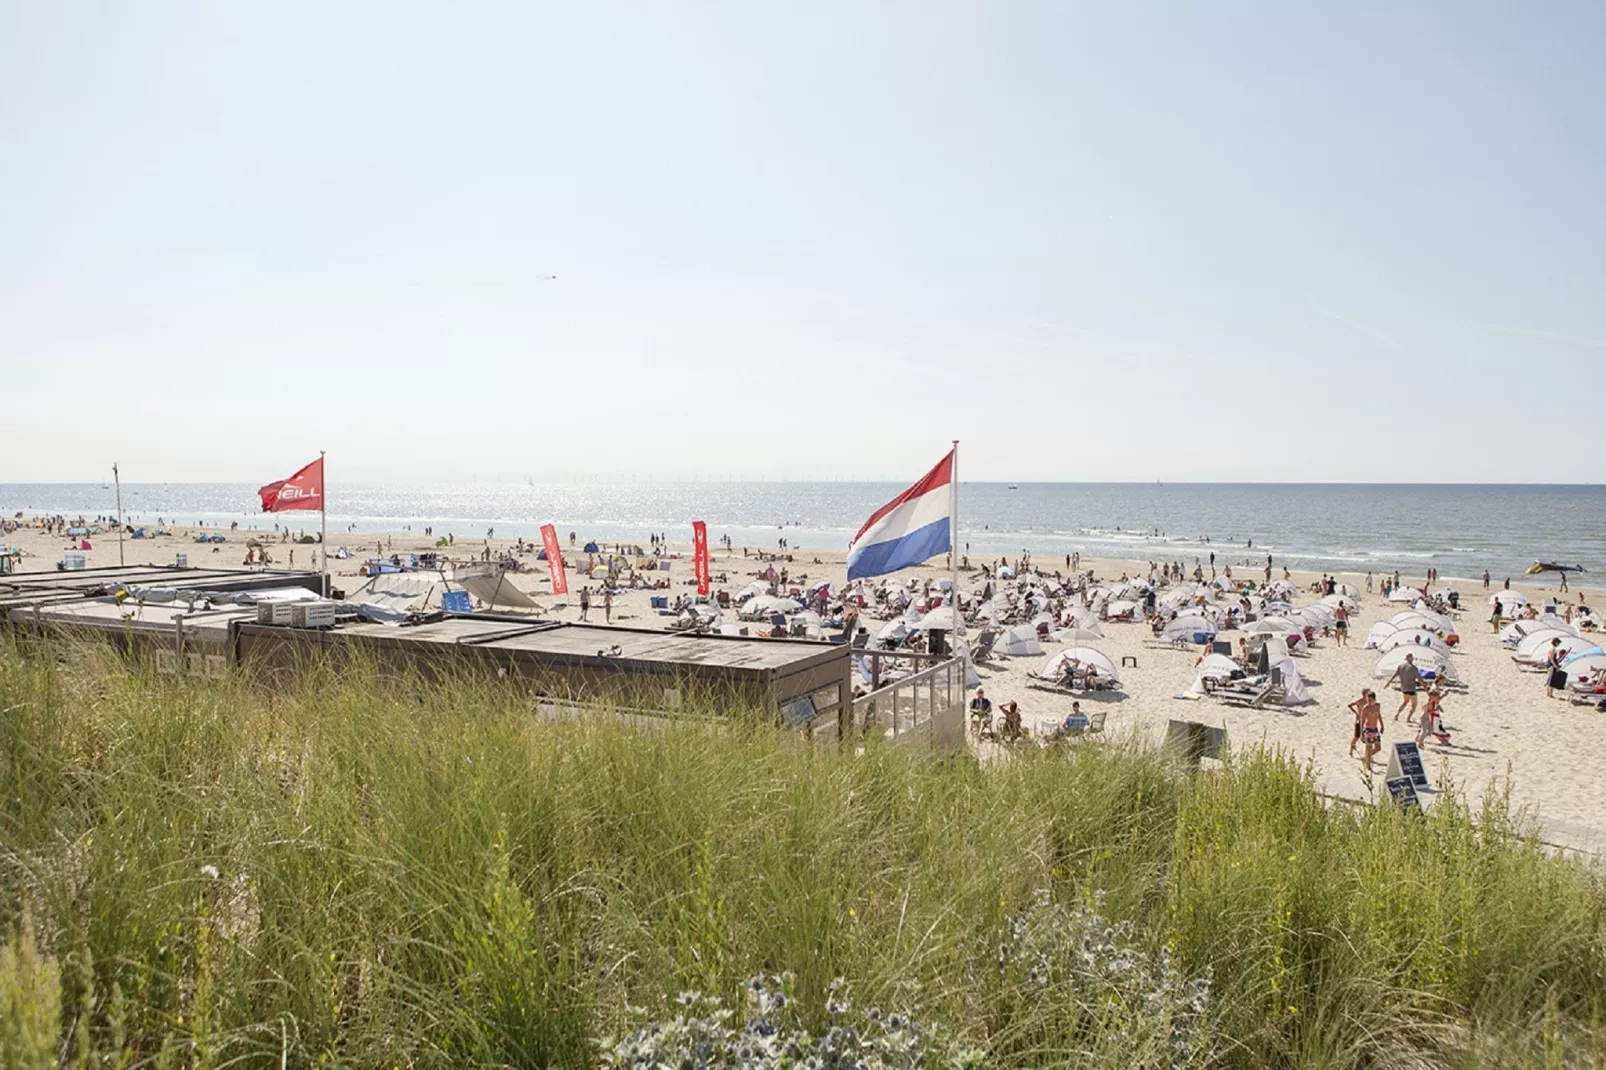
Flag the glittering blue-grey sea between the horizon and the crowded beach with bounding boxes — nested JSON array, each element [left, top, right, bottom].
[[0, 482, 1606, 582]]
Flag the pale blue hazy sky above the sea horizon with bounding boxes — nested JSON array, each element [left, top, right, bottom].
[[0, 0, 1606, 482]]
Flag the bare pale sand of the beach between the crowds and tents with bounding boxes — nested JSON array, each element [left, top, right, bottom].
[[0, 517, 1606, 852]]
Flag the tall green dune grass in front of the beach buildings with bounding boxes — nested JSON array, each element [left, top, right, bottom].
[[0, 641, 1606, 1067]]
